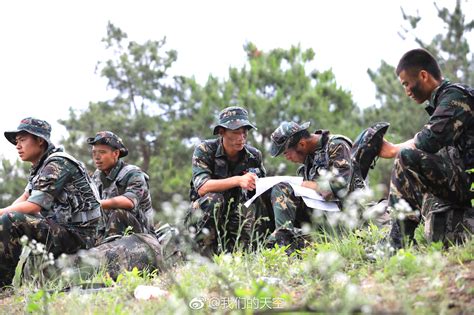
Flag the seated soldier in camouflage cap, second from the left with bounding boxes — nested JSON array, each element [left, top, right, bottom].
[[87, 131, 153, 238]]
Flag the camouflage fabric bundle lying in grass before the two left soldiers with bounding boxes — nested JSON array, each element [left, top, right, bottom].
[[23, 225, 182, 285]]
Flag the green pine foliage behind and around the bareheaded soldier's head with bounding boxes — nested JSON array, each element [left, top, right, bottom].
[[363, 0, 474, 187]]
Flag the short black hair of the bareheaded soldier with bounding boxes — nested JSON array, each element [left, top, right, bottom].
[[395, 48, 442, 80]]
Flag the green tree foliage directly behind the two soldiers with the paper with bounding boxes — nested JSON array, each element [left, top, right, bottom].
[[196, 43, 360, 175]]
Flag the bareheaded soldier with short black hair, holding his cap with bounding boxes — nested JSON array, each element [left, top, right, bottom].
[[380, 49, 474, 248]]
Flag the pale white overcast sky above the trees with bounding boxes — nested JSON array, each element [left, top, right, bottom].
[[0, 0, 474, 158]]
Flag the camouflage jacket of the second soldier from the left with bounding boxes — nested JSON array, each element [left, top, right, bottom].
[[92, 160, 152, 225]]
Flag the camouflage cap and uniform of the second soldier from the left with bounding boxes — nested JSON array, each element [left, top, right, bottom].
[[87, 131, 153, 238]]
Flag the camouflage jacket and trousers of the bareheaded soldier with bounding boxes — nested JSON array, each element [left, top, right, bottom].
[[389, 81, 474, 247]]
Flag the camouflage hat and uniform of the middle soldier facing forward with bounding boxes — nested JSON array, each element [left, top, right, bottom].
[[185, 107, 271, 255]]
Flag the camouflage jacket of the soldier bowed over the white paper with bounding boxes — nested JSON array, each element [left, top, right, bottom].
[[298, 130, 352, 196]]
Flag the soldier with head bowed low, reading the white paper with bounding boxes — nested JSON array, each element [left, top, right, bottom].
[[271, 121, 364, 247]]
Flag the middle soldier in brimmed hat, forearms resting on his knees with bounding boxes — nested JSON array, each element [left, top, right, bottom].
[[185, 107, 272, 255]]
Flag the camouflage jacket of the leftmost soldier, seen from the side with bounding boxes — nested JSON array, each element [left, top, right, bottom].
[[25, 147, 101, 227]]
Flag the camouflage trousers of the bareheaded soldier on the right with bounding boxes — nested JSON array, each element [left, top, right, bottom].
[[388, 148, 472, 248]]
